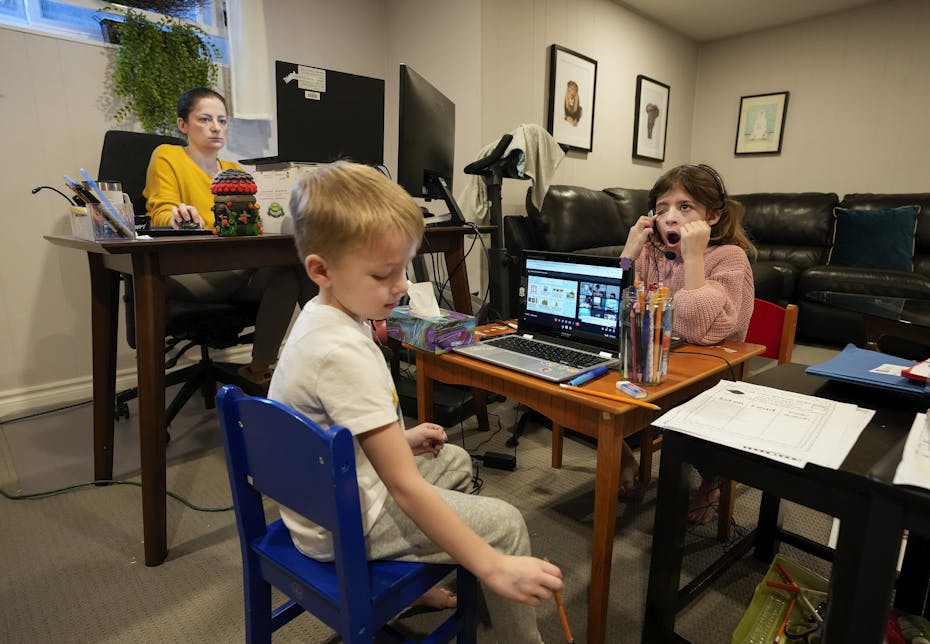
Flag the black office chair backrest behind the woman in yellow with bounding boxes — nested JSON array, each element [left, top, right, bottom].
[[97, 130, 185, 215]]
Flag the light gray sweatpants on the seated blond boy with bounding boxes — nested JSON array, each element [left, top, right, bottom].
[[367, 444, 542, 644]]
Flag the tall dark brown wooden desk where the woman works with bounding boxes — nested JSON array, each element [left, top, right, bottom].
[[45, 227, 487, 566]]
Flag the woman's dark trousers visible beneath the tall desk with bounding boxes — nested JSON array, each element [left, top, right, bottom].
[[165, 266, 316, 365]]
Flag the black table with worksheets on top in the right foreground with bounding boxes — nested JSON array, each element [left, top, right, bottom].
[[642, 364, 930, 643]]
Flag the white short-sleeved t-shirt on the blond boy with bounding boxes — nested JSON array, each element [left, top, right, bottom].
[[268, 296, 403, 561]]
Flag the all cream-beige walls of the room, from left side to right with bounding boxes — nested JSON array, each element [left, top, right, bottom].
[[0, 0, 930, 412]]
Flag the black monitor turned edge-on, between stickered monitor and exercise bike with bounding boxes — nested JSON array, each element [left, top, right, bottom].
[[397, 64, 465, 226]]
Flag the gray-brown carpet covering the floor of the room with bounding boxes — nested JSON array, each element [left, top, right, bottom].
[[0, 347, 835, 644]]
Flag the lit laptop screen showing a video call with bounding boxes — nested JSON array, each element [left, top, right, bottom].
[[519, 251, 633, 353]]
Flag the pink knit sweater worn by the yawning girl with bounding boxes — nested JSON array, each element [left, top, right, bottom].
[[636, 245, 755, 345]]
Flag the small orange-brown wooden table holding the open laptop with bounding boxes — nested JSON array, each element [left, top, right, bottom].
[[416, 341, 765, 644]]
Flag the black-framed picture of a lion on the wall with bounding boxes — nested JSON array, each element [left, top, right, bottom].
[[547, 45, 597, 152]]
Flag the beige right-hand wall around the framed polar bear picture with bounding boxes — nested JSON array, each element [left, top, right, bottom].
[[692, 0, 930, 196]]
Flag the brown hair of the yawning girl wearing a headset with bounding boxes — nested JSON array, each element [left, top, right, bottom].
[[649, 163, 759, 258]]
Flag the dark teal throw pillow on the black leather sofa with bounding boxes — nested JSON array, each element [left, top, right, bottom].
[[827, 206, 920, 271]]
